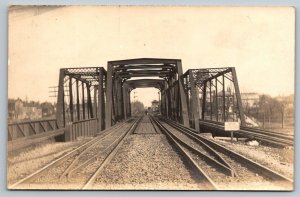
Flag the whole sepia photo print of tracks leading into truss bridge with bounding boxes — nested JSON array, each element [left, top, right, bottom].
[[5, 5, 295, 191]]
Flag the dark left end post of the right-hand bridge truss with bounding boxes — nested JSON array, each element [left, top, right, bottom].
[[189, 70, 200, 132]]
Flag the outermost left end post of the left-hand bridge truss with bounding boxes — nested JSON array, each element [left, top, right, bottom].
[[56, 69, 66, 128]]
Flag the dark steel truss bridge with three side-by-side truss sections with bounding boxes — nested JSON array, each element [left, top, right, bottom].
[[56, 58, 245, 139]]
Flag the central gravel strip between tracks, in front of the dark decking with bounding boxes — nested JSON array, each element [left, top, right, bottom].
[[94, 134, 200, 190]]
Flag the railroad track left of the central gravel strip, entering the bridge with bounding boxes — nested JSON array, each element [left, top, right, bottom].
[[9, 119, 140, 189]]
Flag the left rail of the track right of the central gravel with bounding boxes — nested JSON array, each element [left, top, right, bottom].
[[154, 115, 218, 190]]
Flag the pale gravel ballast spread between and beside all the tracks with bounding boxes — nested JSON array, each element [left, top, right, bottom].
[[7, 115, 294, 190]]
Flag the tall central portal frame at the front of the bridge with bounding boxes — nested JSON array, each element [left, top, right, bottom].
[[105, 58, 189, 128]]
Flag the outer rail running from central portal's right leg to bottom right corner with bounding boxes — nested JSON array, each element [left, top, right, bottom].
[[167, 120, 293, 184]]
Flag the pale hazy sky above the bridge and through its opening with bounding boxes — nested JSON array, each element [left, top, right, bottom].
[[8, 6, 295, 105]]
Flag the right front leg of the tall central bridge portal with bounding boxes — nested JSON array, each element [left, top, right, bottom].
[[176, 60, 189, 126]]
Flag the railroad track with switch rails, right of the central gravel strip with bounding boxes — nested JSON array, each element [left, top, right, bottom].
[[156, 116, 293, 188]]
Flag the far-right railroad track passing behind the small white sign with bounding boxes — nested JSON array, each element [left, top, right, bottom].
[[200, 120, 294, 147]]
